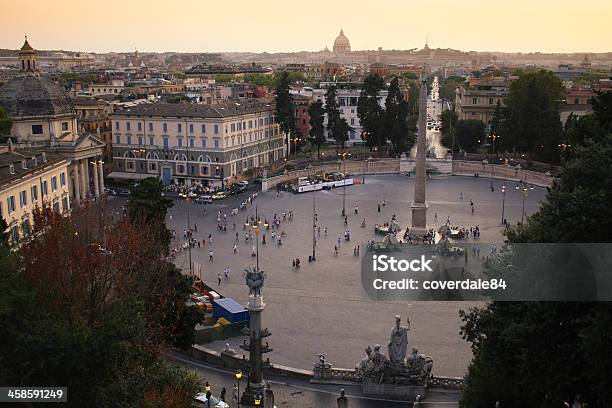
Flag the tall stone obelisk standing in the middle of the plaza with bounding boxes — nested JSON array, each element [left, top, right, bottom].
[[410, 79, 427, 238]]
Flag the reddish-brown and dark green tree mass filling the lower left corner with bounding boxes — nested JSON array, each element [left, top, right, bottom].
[[0, 201, 198, 407]]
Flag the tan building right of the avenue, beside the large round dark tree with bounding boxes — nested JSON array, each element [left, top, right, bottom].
[[455, 78, 510, 126]]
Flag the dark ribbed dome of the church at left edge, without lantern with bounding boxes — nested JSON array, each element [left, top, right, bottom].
[[0, 75, 74, 117]]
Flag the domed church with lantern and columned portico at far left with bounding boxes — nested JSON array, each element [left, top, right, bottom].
[[0, 37, 104, 202]]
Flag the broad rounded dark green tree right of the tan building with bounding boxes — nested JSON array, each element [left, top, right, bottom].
[[498, 70, 565, 162]]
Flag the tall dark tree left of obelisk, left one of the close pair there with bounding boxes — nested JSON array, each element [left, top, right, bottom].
[[357, 75, 384, 153]]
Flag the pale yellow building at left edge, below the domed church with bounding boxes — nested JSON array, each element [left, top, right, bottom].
[[0, 146, 71, 242]]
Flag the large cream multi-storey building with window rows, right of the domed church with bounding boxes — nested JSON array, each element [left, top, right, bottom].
[[109, 100, 287, 185]]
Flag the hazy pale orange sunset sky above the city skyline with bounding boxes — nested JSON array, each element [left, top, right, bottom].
[[0, 0, 612, 52]]
